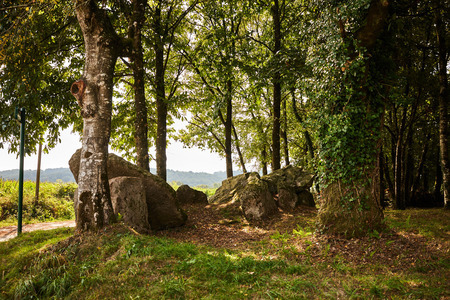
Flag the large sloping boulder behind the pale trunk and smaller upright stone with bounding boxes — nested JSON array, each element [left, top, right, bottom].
[[69, 149, 187, 230]]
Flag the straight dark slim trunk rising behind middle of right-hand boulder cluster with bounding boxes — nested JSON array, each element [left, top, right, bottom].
[[272, 0, 281, 171]]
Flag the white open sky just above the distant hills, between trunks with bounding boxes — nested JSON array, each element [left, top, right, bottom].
[[0, 125, 225, 173]]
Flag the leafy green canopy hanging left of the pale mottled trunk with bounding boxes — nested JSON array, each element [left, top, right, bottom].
[[0, 1, 82, 154]]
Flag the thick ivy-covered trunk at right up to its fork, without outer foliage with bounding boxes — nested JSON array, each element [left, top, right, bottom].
[[318, 0, 389, 236]]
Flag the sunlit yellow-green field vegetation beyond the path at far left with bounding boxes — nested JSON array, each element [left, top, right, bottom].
[[0, 179, 77, 227]]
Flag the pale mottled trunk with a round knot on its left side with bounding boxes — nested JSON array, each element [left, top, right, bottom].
[[71, 0, 120, 231]]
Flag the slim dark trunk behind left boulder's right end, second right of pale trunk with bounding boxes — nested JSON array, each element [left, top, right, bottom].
[[153, 3, 167, 180]]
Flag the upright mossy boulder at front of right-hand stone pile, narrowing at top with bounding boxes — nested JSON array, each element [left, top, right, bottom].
[[234, 173, 278, 221]]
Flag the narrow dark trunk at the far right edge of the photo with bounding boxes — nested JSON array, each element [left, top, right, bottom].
[[435, 1, 450, 209]]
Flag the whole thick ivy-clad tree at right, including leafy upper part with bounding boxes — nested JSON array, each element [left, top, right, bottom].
[[308, 0, 389, 236]]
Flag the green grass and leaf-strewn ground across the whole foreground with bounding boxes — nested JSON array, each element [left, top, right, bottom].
[[0, 209, 450, 299]]
